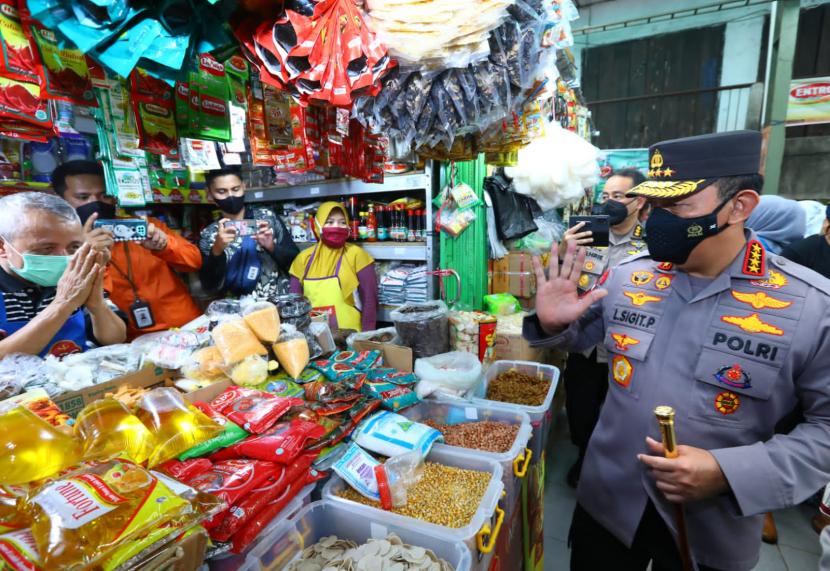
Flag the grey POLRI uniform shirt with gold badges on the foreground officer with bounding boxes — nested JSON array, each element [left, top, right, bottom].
[[524, 233, 830, 569]]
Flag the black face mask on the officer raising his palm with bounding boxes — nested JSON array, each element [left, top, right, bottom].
[[645, 198, 732, 264]]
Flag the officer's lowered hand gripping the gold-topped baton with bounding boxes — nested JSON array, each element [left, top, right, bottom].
[[637, 438, 729, 504]]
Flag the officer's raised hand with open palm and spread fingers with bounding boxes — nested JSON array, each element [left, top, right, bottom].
[[533, 241, 608, 335]]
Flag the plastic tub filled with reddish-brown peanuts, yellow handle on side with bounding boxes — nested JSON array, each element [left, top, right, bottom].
[[401, 399, 533, 520]]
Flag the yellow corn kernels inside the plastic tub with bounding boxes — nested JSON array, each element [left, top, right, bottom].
[[337, 462, 491, 528]]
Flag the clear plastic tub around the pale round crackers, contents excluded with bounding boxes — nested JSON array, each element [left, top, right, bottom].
[[240, 500, 471, 571]]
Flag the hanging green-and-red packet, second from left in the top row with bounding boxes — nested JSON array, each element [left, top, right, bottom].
[[29, 20, 98, 107]]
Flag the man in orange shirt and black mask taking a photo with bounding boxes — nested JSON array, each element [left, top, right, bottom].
[[52, 161, 202, 340]]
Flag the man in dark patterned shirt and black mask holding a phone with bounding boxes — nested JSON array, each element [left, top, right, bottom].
[[199, 168, 300, 299]]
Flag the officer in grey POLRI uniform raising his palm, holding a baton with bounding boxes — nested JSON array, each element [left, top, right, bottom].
[[524, 131, 830, 570]]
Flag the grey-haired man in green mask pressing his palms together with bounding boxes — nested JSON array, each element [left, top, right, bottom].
[[0, 192, 127, 357]]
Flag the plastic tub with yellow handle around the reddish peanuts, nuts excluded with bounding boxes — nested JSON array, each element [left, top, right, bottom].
[[400, 399, 533, 520]]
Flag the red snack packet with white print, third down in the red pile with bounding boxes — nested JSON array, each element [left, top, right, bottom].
[[184, 460, 277, 529]]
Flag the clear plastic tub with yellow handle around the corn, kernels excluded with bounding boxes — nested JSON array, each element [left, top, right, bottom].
[[323, 446, 505, 570]]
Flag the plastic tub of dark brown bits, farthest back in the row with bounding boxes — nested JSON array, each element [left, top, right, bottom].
[[467, 361, 559, 462]]
